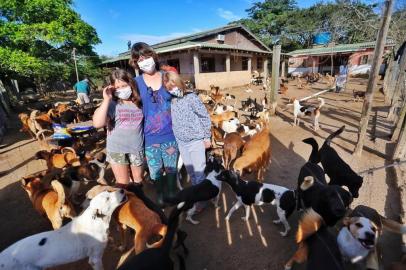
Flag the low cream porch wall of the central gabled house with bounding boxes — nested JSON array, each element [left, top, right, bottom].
[[195, 70, 251, 90]]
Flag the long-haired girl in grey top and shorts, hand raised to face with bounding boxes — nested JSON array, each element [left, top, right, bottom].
[[93, 69, 144, 187]]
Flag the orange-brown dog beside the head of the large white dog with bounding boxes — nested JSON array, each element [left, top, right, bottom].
[[86, 185, 167, 254]]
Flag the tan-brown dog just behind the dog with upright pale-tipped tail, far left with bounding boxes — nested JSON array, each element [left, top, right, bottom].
[[35, 147, 80, 171]]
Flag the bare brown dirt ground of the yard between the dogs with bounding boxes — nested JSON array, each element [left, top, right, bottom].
[[0, 79, 406, 270]]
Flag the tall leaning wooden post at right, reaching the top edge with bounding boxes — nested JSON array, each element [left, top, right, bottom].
[[354, 0, 393, 156]]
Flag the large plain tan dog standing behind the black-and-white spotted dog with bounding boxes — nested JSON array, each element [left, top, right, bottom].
[[233, 125, 271, 181]]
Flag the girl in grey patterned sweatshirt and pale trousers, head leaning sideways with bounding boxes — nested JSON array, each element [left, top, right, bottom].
[[164, 72, 211, 212]]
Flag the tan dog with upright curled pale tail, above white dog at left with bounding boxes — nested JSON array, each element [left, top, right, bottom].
[[21, 174, 76, 230]]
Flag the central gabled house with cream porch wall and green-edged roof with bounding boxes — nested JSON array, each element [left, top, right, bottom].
[[102, 24, 271, 89]]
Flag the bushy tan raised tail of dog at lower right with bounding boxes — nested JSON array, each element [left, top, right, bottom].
[[296, 208, 324, 243]]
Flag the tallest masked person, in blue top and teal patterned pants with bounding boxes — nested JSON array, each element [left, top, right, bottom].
[[130, 42, 178, 206]]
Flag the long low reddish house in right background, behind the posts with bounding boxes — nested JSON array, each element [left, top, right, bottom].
[[288, 41, 394, 76]]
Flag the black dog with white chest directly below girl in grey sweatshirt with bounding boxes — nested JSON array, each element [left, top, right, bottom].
[[166, 155, 224, 225]]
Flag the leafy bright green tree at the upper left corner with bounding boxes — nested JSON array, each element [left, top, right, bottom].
[[0, 0, 100, 90]]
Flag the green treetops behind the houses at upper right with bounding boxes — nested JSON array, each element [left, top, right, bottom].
[[240, 0, 379, 51]]
